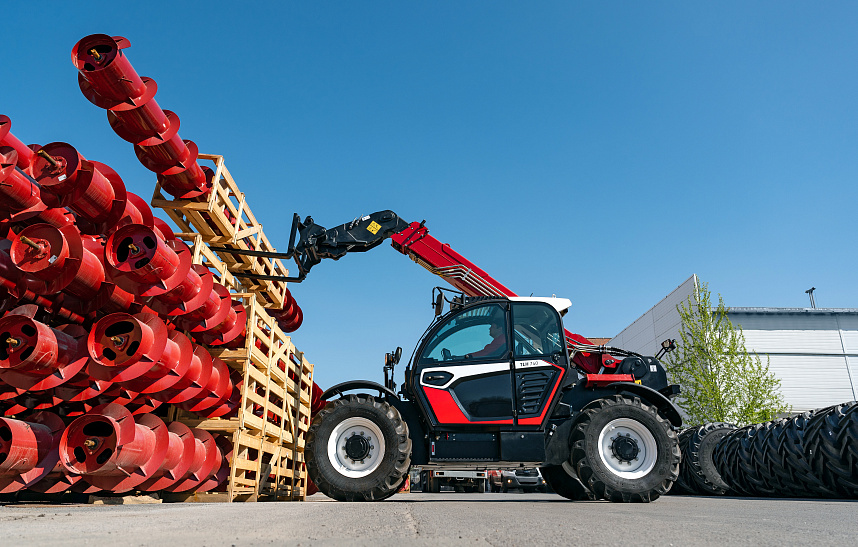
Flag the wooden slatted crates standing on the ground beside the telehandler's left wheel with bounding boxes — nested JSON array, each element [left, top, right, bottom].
[[170, 293, 313, 501]]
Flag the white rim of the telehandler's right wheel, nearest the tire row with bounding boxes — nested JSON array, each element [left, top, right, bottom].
[[599, 418, 658, 479]]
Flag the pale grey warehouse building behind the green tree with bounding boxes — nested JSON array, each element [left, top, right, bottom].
[[609, 275, 858, 411]]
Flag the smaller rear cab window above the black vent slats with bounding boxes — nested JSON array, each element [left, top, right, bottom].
[[512, 302, 564, 357]]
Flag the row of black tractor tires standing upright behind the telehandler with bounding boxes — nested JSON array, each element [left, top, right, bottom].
[[671, 401, 858, 499]]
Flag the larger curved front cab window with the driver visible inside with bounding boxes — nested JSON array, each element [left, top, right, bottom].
[[418, 304, 509, 364]]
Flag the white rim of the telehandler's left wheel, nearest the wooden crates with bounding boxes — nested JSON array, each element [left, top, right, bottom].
[[328, 417, 385, 479]]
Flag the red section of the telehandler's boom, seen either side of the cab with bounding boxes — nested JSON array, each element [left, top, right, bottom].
[[390, 222, 602, 374]]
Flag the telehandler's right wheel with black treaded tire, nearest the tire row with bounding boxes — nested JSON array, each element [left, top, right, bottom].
[[571, 395, 681, 503]]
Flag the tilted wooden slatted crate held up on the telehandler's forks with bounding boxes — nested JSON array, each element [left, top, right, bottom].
[[152, 154, 289, 309]]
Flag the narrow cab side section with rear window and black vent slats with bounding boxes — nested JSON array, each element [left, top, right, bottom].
[[512, 302, 569, 426]]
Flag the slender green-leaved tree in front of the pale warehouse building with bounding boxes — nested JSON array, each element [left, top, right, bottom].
[[666, 282, 790, 425]]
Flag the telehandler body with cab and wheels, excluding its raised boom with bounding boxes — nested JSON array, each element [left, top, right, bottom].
[[306, 288, 681, 502]]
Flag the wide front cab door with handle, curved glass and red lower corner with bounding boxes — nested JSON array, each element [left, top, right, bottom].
[[414, 303, 514, 426]]
